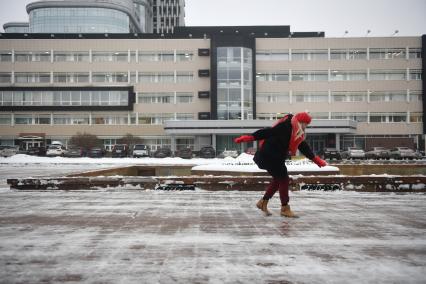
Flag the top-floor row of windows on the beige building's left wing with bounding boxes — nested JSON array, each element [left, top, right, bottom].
[[0, 50, 194, 62]]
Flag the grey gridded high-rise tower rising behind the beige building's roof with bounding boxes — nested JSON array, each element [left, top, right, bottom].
[[153, 0, 185, 34]]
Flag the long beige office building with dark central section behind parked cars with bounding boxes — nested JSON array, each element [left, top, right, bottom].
[[0, 26, 426, 155]]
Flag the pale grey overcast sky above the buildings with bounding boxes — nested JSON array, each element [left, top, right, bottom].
[[0, 0, 426, 37]]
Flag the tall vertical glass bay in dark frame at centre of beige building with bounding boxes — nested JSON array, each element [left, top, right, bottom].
[[217, 47, 253, 120]]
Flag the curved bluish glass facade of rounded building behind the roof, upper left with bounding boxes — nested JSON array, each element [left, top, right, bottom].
[[29, 7, 136, 33]]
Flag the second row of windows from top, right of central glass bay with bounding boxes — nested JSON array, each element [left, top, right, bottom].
[[256, 68, 422, 82]]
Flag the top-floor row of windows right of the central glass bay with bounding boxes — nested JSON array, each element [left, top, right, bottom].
[[256, 47, 422, 61]]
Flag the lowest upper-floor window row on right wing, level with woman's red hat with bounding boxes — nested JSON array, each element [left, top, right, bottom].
[[257, 112, 423, 123]]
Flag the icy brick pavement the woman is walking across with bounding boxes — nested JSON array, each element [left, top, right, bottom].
[[0, 189, 426, 283]]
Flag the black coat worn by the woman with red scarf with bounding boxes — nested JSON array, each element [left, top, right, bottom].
[[252, 114, 315, 177]]
